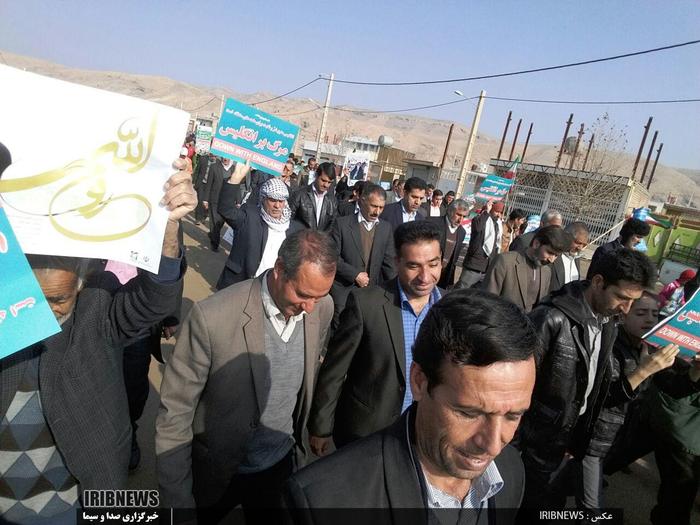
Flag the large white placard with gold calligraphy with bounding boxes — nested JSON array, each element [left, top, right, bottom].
[[0, 66, 189, 272]]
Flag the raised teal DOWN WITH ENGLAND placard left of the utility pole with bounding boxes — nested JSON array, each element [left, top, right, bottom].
[[211, 98, 299, 175]]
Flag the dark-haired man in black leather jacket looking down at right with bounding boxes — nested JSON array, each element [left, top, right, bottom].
[[520, 248, 656, 509]]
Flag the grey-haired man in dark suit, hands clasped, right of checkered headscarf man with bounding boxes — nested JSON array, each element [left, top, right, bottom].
[[331, 183, 396, 328]]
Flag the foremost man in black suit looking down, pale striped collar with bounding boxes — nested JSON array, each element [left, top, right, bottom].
[[286, 290, 542, 525]]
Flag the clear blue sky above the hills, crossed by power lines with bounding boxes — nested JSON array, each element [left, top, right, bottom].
[[0, 0, 700, 169]]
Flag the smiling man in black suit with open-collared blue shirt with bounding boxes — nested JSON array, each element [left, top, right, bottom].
[[308, 221, 442, 455]]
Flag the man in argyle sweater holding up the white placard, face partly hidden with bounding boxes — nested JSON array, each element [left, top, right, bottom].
[[0, 146, 197, 524]]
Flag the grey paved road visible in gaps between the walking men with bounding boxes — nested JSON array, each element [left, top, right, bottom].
[[129, 215, 700, 525]]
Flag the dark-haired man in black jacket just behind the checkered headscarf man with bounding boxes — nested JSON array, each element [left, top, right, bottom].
[[289, 162, 338, 231]]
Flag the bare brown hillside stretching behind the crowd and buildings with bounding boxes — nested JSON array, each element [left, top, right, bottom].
[[2, 51, 700, 204]]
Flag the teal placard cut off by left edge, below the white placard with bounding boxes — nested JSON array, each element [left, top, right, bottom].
[[0, 208, 61, 359]]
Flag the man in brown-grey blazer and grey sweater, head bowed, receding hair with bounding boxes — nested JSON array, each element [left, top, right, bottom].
[[156, 230, 337, 523]]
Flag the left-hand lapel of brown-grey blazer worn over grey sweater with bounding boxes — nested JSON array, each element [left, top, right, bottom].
[[243, 272, 267, 414]]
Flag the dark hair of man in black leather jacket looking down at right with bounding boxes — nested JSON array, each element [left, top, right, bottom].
[[588, 248, 656, 288]]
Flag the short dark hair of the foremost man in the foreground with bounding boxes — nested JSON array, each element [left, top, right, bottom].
[[413, 288, 543, 391]]
